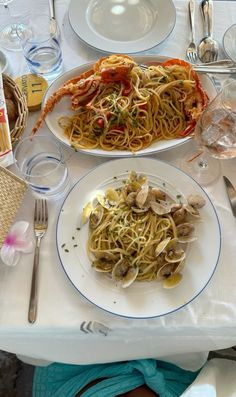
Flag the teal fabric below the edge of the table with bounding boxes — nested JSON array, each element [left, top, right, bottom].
[[33, 359, 199, 397]]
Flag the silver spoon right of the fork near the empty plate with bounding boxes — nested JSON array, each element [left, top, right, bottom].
[[198, 0, 219, 63]]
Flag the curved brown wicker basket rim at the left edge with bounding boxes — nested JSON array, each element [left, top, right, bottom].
[[2, 74, 28, 146]]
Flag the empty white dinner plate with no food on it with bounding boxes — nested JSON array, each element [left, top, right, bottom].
[[69, 0, 176, 54]]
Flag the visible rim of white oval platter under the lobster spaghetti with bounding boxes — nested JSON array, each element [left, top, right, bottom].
[[43, 55, 216, 157]]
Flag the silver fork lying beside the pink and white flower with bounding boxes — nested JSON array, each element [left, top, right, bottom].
[[28, 199, 48, 323]]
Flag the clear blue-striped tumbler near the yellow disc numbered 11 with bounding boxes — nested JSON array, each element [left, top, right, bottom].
[[18, 13, 62, 81]]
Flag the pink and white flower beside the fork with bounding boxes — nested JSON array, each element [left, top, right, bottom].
[[0, 221, 34, 266]]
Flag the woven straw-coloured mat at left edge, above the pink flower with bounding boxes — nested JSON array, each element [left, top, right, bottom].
[[0, 166, 28, 247]]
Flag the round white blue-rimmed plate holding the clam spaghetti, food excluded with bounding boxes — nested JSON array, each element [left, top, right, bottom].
[[56, 157, 221, 318]]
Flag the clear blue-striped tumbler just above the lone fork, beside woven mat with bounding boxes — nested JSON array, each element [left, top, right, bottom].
[[14, 135, 70, 199]]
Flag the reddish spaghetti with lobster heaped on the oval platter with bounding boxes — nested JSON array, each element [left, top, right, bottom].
[[59, 55, 207, 152]]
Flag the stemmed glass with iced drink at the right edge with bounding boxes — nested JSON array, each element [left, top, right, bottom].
[[181, 79, 236, 185]]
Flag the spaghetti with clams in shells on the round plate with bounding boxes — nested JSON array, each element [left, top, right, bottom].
[[83, 172, 204, 288]]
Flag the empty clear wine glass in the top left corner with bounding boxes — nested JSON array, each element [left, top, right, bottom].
[[0, 0, 27, 51]]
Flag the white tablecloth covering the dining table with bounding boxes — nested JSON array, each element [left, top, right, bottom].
[[0, 0, 236, 370]]
